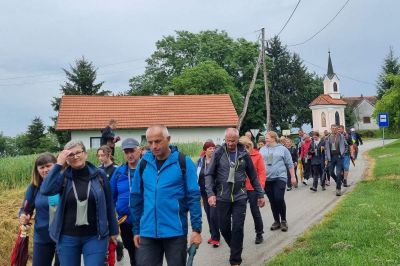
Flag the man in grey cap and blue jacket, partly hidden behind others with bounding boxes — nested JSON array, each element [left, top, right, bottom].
[[110, 138, 140, 265]]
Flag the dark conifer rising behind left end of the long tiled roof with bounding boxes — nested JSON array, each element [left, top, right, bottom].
[[49, 57, 111, 145]]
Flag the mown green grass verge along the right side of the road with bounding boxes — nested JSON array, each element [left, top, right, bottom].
[[267, 141, 400, 265]]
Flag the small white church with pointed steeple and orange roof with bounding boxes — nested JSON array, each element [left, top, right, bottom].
[[309, 52, 347, 133]]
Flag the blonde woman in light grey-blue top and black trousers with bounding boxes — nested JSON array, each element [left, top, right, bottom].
[[260, 131, 297, 232]]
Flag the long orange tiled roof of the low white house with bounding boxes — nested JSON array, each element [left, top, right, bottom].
[[57, 94, 238, 130]]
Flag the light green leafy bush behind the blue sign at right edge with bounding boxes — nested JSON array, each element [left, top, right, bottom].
[[373, 75, 400, 132]]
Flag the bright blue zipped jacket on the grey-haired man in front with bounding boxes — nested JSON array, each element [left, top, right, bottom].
[[130, 146, 201, 238]]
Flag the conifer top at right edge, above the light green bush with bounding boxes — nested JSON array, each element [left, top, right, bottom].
[[377, 47, 400, 99]]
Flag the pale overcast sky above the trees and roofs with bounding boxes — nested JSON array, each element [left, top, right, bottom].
[[0, 0, 400, 136]]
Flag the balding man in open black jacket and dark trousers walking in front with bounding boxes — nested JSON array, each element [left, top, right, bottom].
[[205, 128, 265, 265]]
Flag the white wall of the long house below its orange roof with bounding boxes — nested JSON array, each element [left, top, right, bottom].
[[71, 127, 226, 149]]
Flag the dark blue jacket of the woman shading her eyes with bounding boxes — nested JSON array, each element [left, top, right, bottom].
[[40, 162, 118, 242]]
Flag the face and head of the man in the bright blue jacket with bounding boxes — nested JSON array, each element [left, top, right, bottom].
[[146, 128, 171, 160]]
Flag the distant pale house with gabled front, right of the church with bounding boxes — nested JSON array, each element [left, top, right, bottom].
[[343, 95, 379, 130]]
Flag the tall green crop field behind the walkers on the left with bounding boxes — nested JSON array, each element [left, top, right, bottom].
[[0, 142, 203, 192]]
